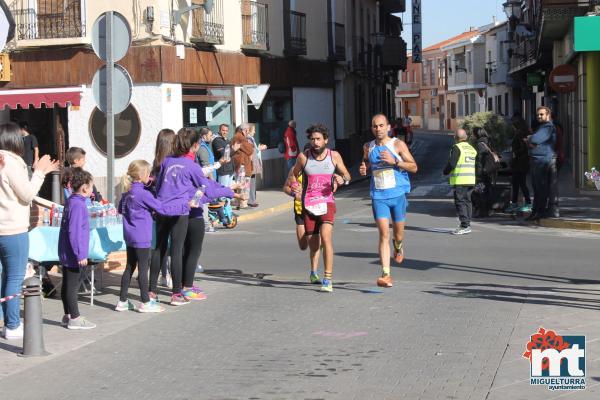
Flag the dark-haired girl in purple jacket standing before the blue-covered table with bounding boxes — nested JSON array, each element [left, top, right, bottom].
[[58, 168, 96, 329]]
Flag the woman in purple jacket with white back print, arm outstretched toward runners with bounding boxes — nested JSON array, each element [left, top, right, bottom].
[[152, 128, 239, 306]]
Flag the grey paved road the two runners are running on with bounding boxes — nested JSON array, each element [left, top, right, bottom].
[[0, 135, 600, 399]]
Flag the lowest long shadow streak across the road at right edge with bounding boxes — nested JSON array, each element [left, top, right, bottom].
[[424, 283, 600, 310]]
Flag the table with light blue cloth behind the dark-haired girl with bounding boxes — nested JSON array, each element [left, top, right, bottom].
[[29, 224, 125, 305]]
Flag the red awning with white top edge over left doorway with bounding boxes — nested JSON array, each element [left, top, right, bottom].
[[0, 86, 83, 110]]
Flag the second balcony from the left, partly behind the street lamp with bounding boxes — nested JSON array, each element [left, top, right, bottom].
[[190, 0, 225, 45]]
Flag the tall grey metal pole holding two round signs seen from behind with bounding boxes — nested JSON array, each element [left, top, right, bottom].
[[106, 11, 115, 204]]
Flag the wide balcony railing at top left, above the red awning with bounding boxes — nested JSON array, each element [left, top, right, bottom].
[[10, 0, 86, 40]]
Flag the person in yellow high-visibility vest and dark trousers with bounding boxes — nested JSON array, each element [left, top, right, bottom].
[[444, 129, 477, 235]]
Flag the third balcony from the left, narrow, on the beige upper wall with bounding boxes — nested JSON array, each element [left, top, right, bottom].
[[242, 0, 269, 50]]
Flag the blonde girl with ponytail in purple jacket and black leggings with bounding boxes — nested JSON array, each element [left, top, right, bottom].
[[115, 160, 165, 313]]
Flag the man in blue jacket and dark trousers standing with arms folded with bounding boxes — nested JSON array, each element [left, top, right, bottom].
[[525, 106, 556, 221]]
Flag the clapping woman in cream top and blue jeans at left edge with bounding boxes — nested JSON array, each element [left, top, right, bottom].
[[0, 123, 59, 339]]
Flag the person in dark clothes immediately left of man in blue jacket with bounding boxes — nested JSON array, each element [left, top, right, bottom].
[[506, 116, 531, 213]]
